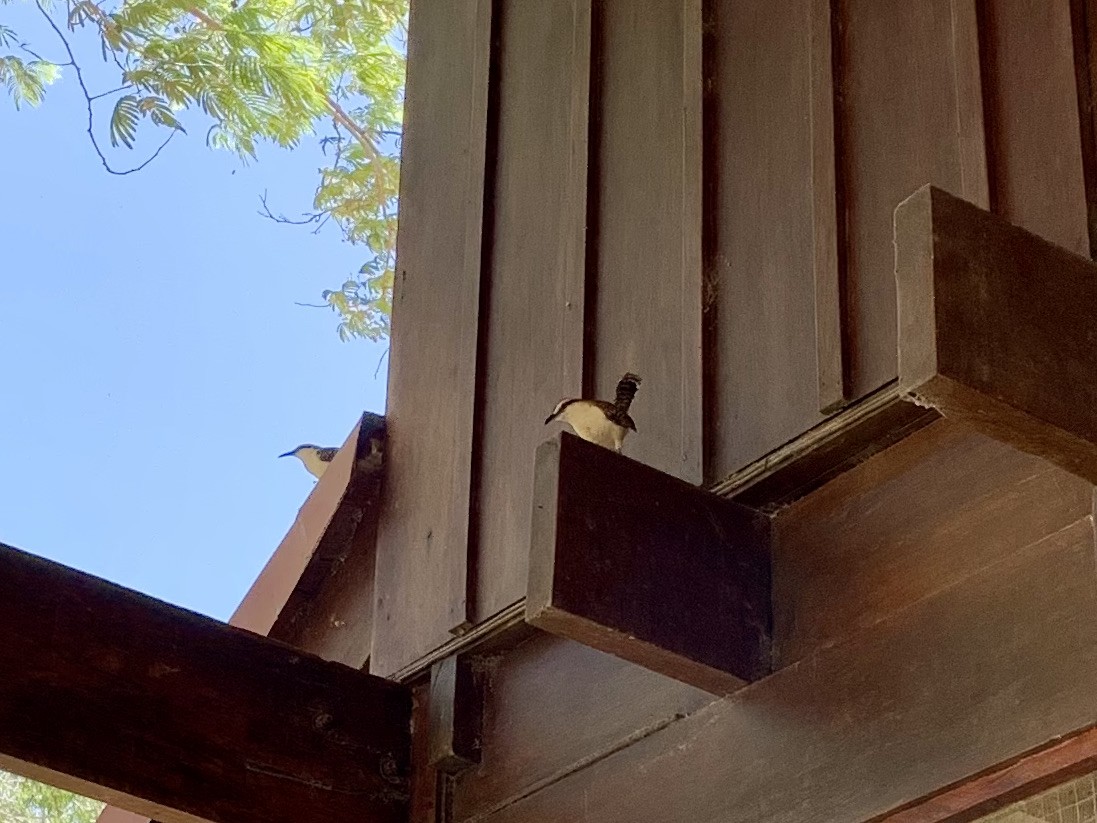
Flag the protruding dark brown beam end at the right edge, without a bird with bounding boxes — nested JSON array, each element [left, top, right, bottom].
[[895, 187, 1097, 483]]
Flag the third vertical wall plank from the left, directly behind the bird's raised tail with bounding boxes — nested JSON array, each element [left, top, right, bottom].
[[586, 0, 702, 482]]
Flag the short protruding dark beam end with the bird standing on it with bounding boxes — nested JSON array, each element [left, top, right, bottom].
[[525, 432, 771, 694]]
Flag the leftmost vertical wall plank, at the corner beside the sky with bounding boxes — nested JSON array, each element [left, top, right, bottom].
[[370, 0, 491, 674]]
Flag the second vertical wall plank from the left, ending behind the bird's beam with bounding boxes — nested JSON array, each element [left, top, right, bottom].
[[473, 0, 590, 622]]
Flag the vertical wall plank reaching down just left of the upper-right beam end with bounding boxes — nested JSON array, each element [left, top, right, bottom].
[[834, 0, 986, 398]]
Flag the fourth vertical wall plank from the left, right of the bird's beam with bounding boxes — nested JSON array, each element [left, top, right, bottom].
[[706, 0, 824, 481]]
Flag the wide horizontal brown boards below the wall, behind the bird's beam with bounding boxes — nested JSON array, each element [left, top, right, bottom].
[[453, 420, 1097, 823]]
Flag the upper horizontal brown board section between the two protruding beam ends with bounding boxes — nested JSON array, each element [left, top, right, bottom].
[[773, 420, 1092, 667]]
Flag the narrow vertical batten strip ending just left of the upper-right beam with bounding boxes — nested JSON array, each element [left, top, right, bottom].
[[811, 0, 846, 414]]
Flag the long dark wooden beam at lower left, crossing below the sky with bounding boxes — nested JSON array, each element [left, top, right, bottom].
[[0, 545, 411, 823]]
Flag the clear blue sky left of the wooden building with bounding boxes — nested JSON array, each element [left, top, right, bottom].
[[0, 3, 387, 619]]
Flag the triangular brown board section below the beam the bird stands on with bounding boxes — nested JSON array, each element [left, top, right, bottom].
[[453, 633, 713, 821]]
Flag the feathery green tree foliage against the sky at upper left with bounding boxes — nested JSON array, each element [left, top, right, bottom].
[[0, 0, 408, 339]]
